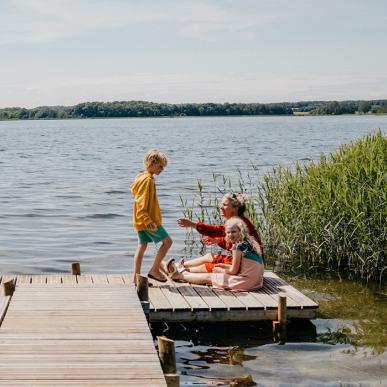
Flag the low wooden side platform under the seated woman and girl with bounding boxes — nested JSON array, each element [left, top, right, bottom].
[[149, 271, 318, 322]]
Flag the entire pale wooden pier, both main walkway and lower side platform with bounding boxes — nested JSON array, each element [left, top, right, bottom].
[[0, 272, 318, 386]]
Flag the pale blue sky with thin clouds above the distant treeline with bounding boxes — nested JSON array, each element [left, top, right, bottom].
[[0, 0, 387, 108]]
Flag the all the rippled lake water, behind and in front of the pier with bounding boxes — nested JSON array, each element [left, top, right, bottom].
[[0, 116, 387, 386]]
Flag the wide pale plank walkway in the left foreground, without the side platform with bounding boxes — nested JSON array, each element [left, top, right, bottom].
[[0, 275, 166, 386]]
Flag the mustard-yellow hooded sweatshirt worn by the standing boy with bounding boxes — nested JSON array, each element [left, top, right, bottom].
[[131, 172, 162, 231]]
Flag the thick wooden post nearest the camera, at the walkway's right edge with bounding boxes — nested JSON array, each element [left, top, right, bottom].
[[157, 336, 180, 387]]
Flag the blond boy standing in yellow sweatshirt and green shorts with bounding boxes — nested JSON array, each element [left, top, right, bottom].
[[131, 149, 172, 282]]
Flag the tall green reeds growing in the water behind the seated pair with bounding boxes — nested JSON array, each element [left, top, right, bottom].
[[181, 130, 387, 284]]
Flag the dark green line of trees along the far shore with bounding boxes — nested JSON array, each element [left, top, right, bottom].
[[0, 99, 387, 121]]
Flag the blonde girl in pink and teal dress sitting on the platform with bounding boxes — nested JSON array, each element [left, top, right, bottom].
[[168, 218, 265, 291]]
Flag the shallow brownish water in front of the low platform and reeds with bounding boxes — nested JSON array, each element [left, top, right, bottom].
[[152, 273, 387, 386]]
